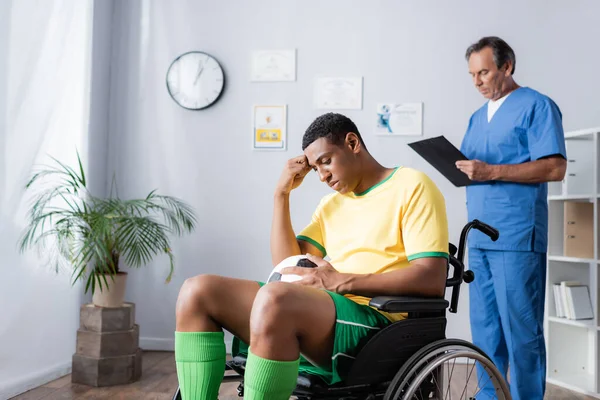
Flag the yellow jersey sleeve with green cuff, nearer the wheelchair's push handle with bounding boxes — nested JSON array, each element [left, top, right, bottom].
[[401, 174, 449, 261]]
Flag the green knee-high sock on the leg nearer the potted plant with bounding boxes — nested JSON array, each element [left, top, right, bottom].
[[175, 332, 225, 400]]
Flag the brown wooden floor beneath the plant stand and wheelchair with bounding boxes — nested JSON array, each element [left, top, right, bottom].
[[11, 351, 594, 400]]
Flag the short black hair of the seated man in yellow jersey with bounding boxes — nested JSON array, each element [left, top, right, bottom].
[[302, 113, 366, 151]]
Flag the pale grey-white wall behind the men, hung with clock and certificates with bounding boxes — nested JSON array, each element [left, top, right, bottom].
[[107, 0, 600, 349]]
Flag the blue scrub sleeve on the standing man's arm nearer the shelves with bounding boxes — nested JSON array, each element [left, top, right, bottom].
[[527, 99, 567, 161]]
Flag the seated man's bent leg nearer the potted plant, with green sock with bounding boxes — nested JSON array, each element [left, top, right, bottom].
[[175, 275, 259, 400]]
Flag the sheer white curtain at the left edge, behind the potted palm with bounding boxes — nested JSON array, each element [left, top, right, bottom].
[[0, 0, 93, 399]]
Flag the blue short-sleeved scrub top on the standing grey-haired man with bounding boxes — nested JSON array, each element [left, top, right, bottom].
[[461, 87, 566, 253]]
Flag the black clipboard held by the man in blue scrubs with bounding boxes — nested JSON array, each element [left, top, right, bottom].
[[408, 136, 473, 187]]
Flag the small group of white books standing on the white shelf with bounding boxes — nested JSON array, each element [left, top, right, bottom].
[[552, 281, 594, 320]]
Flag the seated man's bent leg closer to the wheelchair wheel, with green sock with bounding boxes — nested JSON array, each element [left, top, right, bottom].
[[245, 282, 336, 400]]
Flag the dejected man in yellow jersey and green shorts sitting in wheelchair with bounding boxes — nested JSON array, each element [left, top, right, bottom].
[[175, 113, 448, 400]]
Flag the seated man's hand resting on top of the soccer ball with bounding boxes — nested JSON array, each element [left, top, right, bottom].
[[281, 254, 345, 293]]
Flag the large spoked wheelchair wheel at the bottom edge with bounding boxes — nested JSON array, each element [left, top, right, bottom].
[[384, 339, 512, 400]]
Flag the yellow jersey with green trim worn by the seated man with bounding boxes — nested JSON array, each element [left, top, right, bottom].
[[297, 167, 448, 320]]
